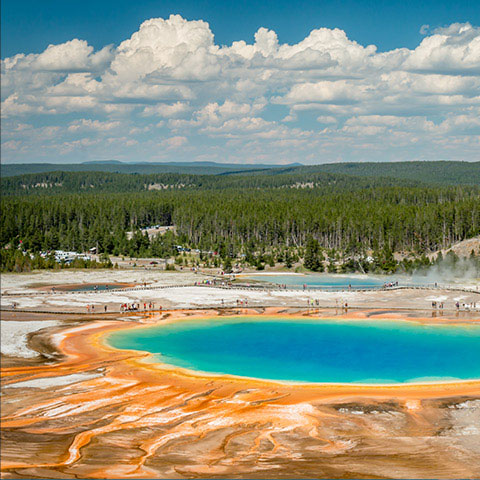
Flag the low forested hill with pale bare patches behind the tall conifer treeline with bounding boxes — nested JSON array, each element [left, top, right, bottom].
[[1, 170, 421, 195]]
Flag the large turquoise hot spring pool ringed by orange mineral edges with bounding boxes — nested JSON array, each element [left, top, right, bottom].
[[108, 317, 480, 384]]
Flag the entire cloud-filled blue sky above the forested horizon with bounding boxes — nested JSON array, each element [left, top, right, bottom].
[[1, 0, 480, 163]]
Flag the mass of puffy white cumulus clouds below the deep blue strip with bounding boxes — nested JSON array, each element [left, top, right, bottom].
[[1, 15, 480, 162]]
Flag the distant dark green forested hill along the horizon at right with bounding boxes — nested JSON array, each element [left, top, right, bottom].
[[227, 162, 480, 185]]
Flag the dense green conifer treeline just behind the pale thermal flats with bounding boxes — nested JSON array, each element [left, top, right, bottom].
[[0, 186, 480, 270]]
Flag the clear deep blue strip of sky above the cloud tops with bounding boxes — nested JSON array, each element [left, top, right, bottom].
[[2, 0, 480, 58]]
